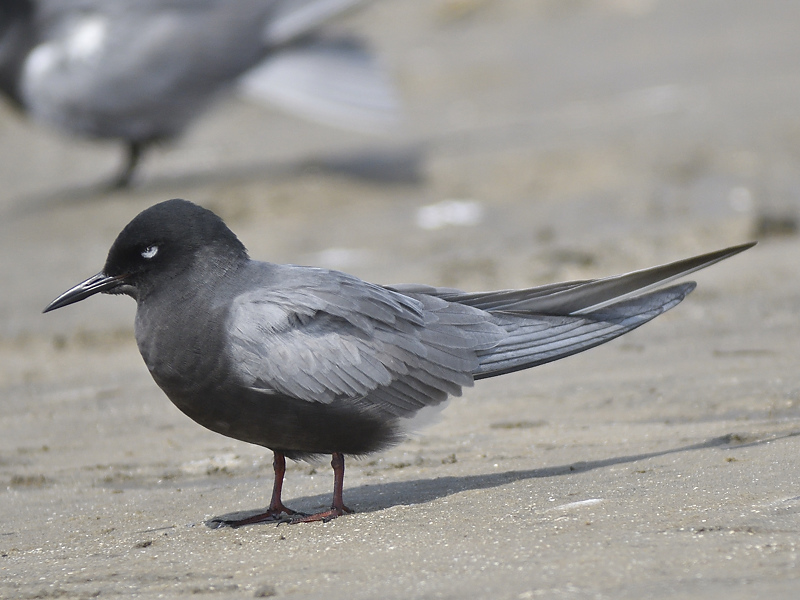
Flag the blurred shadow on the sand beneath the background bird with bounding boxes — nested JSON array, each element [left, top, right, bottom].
[[4, 144, 426, 218]]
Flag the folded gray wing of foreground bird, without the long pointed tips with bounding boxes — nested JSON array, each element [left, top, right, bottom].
[[222, 267, 504, 417]]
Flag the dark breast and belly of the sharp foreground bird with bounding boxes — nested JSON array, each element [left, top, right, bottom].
[[136, 292, 404, 458]]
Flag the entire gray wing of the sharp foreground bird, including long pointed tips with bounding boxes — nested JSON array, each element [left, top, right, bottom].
[[228, 245, 751, 416]]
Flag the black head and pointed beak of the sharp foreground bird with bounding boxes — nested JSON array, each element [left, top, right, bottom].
[[44, 200, 247, 312]]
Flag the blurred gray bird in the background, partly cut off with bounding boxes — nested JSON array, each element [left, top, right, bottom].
[[0, 0, 399, 188]]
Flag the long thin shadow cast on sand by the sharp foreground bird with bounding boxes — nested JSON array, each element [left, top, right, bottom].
[[205, 431, 800, 528]]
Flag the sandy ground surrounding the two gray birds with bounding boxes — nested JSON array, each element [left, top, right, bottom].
[[0, 0, 800, 600]]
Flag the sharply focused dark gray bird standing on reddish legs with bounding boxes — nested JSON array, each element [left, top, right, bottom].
[[44, 199, 755, 527]]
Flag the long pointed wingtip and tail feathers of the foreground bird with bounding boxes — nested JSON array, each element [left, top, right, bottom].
[[393, 243, 754, 379]]
